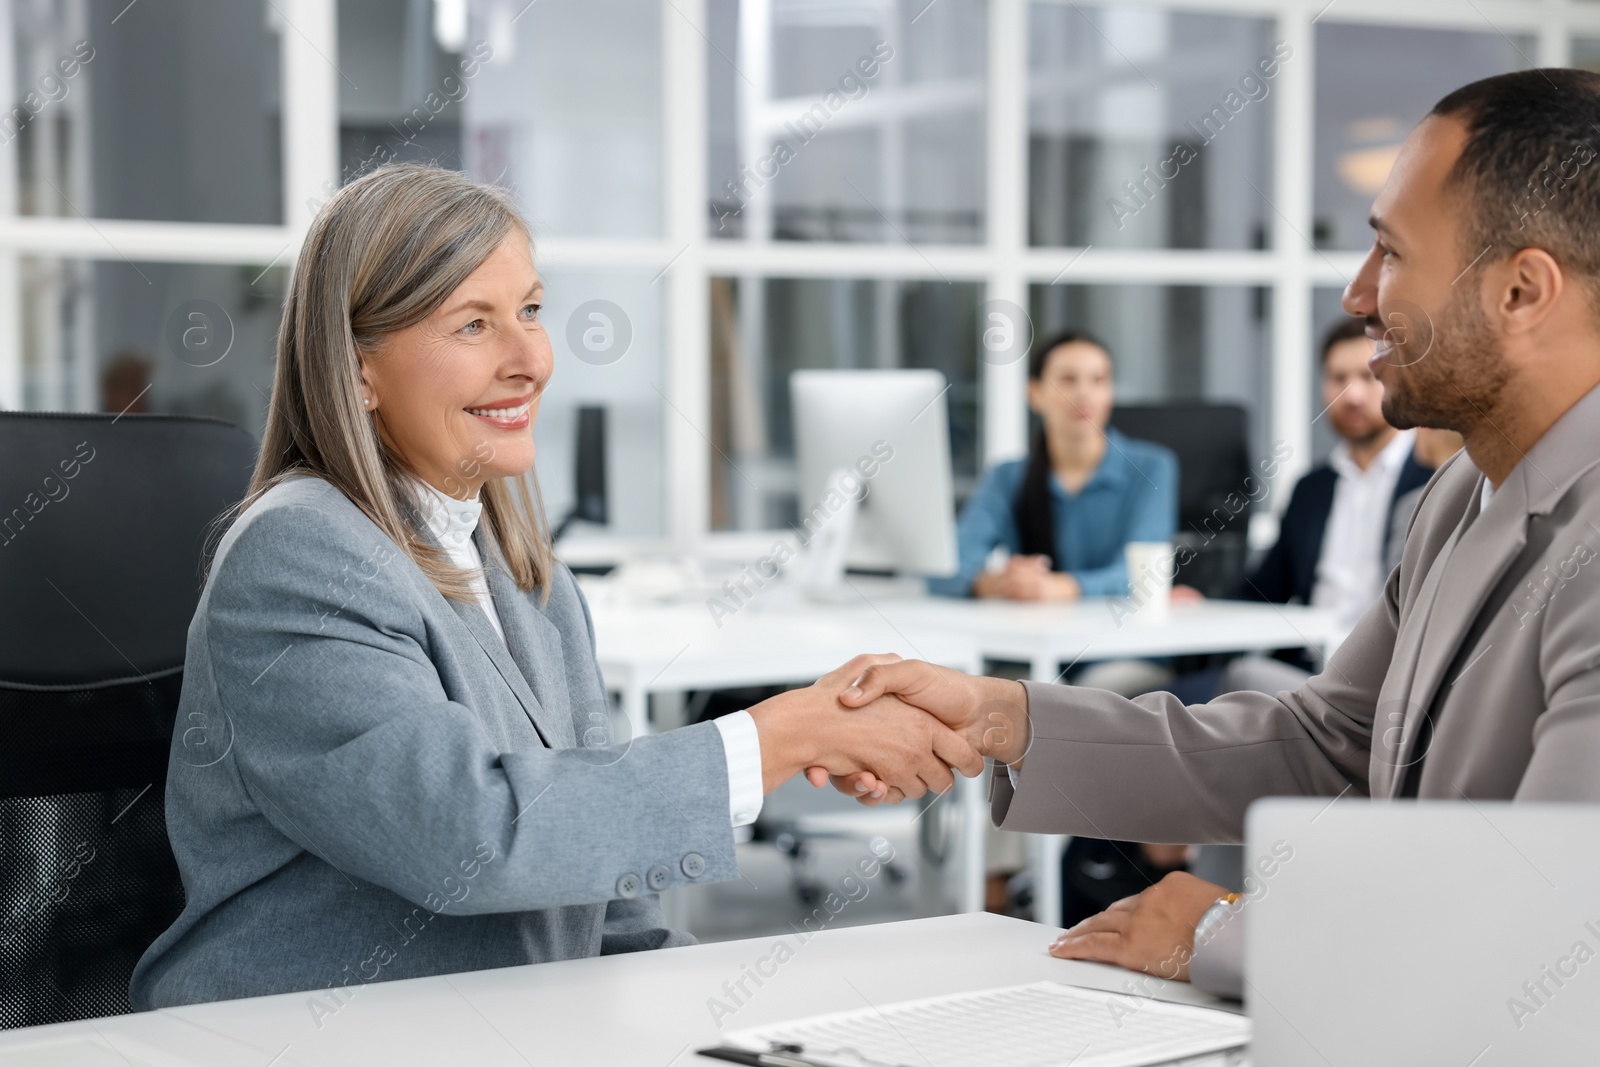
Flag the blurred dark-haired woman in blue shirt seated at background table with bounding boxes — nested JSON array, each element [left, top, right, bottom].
[[928, 331, 1178, 600]]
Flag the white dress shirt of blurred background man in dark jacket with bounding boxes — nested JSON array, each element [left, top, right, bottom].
[[1310, 430, 1416, 645]]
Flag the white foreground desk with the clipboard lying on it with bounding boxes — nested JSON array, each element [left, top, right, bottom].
[[0, 915, 1235, 1067]]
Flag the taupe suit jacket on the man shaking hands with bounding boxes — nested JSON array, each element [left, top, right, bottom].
[[992, 389, 1600, 843]]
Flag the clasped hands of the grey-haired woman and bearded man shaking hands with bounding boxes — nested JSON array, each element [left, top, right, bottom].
[[749, 656, 1029, 805]]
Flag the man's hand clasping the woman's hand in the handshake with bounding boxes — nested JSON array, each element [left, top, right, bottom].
[[806, 659, 1030, 805]]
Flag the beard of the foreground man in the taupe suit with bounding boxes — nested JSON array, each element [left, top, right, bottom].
[[1379, 288, 1510, 434]]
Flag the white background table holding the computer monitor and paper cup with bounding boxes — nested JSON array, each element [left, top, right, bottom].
[[586, 579, 1338, 920]]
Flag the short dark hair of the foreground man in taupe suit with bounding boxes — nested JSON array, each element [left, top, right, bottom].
[[1430, 67, 1600, 318]]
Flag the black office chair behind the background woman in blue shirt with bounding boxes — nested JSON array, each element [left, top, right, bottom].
[[1110, 402, 1261, 597]]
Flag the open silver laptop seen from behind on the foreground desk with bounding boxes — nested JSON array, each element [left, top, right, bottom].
[[1245, 796, 1600, 1067]]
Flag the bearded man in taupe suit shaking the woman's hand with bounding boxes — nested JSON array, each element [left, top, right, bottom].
[[819, 70, 1600, 993]]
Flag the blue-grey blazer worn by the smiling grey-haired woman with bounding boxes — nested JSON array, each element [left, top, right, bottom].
[[131, 477, 738, 1021]]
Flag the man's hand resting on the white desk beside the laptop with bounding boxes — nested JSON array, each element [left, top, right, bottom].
[[1050, 870, 1227, 982]]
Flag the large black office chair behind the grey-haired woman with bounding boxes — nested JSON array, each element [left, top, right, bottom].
[[0, 413, 256, 1029]]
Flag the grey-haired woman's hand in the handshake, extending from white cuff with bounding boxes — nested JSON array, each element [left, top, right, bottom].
[[750, 656, 984, 797]]
